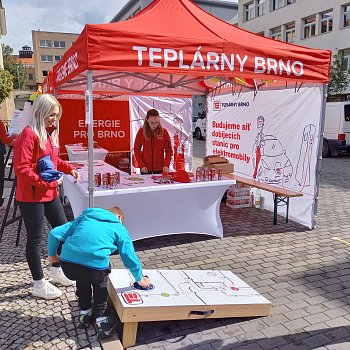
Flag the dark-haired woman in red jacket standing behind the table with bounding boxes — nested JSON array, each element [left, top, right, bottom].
[[134, 109, 173, 174]]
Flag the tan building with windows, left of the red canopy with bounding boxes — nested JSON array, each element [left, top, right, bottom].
[[32, 30, 79, 85]]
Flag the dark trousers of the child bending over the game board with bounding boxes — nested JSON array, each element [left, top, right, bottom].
[[61, 261, 111, 318]]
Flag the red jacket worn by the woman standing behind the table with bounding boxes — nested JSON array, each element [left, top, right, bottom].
[[134, 128, 173, 171]]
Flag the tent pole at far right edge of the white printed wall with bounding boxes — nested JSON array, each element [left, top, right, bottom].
[[312, 84, 327, 228]]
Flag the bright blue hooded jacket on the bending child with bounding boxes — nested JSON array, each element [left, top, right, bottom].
[[48, 208, 142, 281]]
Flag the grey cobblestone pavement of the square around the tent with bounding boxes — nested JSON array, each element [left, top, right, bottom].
[[0, 144, 350, 350]]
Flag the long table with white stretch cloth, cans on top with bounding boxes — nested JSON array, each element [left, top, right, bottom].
[[63, 162, 236, 240]]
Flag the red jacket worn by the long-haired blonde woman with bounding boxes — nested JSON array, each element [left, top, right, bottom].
[[13, 126, 74, 202]]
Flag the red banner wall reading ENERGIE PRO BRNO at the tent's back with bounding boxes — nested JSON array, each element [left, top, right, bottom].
[[59, 99, 130, 153]]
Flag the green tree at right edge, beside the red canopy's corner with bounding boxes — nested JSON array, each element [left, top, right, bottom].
[[328, 51, 350, 94]]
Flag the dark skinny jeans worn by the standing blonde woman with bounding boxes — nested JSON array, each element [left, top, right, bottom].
[[18, 198, 67, 280]]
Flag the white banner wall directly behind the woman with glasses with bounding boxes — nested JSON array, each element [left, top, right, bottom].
[[129, 96, 192, 173]]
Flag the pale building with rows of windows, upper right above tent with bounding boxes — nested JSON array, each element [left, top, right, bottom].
[[238, 0, 350, 94]]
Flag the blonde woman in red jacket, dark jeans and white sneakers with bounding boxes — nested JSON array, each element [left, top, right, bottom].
[[13, 94, 79, 299]]
